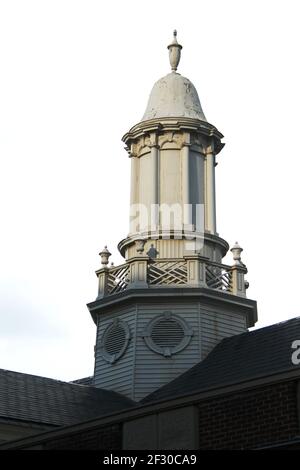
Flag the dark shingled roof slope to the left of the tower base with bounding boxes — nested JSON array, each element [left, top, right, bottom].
[[0, 369, 135, 426]]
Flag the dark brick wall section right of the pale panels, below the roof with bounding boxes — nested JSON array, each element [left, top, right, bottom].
[[199, 382, 299, 449]]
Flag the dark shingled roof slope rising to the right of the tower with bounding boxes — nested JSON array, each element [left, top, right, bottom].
[[142, 317, 300, 404]]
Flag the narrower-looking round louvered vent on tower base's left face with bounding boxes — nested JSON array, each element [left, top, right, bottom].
[[100, 320, 130, 363]]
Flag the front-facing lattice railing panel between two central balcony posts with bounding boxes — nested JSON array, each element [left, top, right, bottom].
[[148, 260, 187, 285]]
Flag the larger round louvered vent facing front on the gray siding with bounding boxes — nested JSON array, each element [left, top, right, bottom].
[[143, 312, 193, 356]]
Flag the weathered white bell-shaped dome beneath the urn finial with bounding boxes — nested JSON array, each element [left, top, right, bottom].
[[142, 72, 206, 121]]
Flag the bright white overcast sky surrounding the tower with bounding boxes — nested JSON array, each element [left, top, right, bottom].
[[0, 0, 300, 380]]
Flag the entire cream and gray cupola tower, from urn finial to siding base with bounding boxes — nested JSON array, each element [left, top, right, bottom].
[[88, 32, 257, 400]]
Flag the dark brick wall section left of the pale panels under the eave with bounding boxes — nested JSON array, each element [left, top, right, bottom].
[[44, 424, 122, 450]]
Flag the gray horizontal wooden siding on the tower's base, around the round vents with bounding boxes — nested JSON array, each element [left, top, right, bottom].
[[95, 302, 247, 401]]
